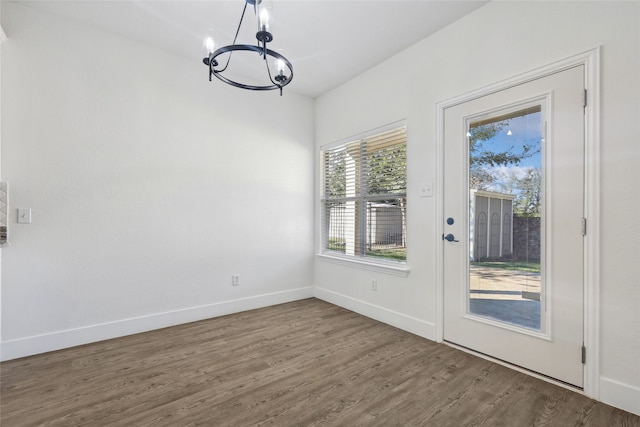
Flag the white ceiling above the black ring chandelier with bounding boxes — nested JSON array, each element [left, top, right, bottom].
[[15, 0, 487, 97]]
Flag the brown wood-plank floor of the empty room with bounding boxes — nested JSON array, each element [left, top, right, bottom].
[[0, 299, 640, 427]]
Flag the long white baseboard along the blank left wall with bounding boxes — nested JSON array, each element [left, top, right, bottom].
[[0, 287, 313, 361]]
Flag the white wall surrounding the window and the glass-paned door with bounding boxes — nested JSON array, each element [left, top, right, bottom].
[[315, 2, 640, 414]]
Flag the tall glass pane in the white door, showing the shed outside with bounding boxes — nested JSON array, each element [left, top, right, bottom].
[[467, 105, 544, 331]]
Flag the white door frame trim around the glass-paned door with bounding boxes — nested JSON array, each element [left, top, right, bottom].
[[435, 46, 601, 399]]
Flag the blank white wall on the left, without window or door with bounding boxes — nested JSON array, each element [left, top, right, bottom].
[[1, 2, 314, 359]]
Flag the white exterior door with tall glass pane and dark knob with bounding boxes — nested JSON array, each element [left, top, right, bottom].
[[443, 65, 584, 387]]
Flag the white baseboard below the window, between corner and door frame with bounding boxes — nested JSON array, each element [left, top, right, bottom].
[[313, 286, 436, 341]]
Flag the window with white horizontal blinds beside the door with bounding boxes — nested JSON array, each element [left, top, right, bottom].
[[322, 127, 407, 262]]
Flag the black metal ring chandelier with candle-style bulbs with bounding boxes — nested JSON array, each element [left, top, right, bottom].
[[202, 0, 293, 96]]
